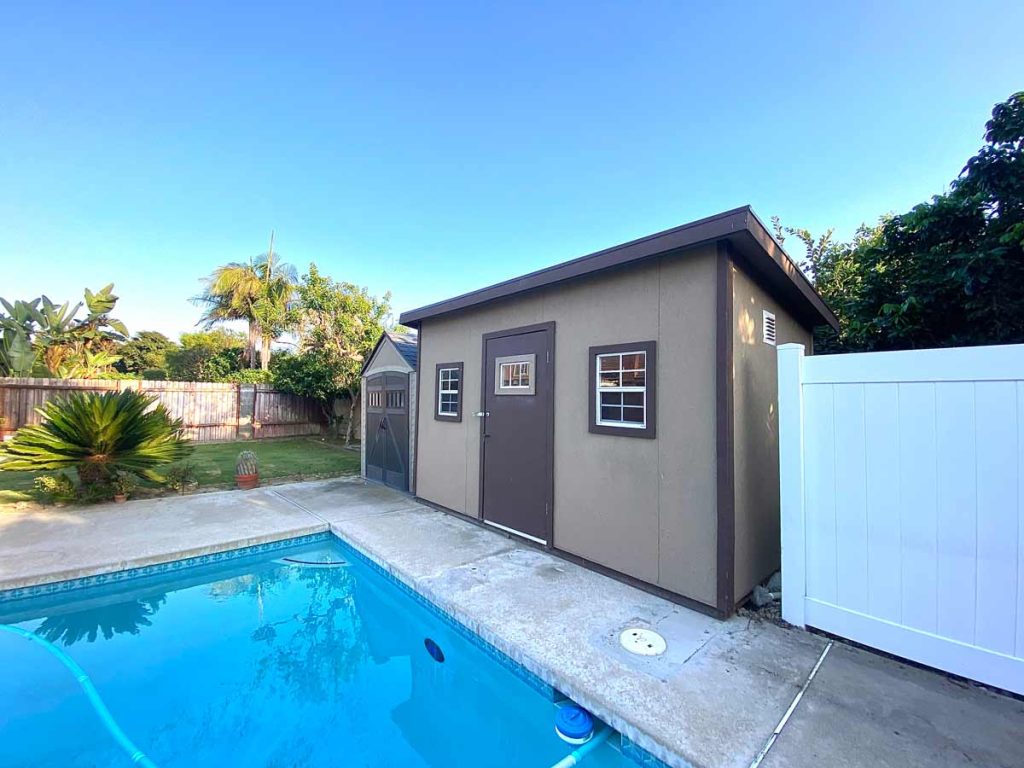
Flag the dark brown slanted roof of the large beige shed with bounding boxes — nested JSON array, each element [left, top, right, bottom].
[[399, 206, 839, 329]]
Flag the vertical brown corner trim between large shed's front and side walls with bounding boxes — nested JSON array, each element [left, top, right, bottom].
[[715, 241, 736, 615]]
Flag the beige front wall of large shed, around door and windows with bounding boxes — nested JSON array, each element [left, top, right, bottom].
[[416, 246, 718, 605]]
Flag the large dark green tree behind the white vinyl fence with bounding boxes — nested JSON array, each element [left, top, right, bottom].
[[776, 92, 1024, 351]]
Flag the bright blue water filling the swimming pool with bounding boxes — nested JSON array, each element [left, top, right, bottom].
[[0, 539, 636, 768]]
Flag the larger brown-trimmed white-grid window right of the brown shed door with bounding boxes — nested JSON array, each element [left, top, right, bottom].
[[589, 341, 657, 439]]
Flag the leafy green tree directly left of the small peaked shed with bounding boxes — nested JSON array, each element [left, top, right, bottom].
[[273, 264, 391, 444]]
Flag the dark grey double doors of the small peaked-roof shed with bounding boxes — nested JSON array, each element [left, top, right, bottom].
[[365, 373, 409, 490]]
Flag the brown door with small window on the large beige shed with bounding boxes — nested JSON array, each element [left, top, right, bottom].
[[480, 327, 554, 544]]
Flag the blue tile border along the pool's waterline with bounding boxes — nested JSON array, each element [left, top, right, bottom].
[[0, 530, 671, 768]]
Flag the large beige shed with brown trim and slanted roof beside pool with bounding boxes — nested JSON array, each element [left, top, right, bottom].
[[400, 206, 837, 615]]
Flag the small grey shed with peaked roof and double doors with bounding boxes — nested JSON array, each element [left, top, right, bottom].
[[359, 331, 419, 490]]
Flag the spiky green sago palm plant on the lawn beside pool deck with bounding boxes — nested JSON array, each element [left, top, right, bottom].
[[0, 390, 191, 487]]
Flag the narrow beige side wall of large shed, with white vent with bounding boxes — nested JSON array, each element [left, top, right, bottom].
[[732, 266, 811, 600]]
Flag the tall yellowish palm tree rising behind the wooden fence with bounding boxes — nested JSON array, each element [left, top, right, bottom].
[[194, 233, 298, 371]]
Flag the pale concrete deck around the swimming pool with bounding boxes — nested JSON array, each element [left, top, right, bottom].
[[0, 478, 1024, 768]]
